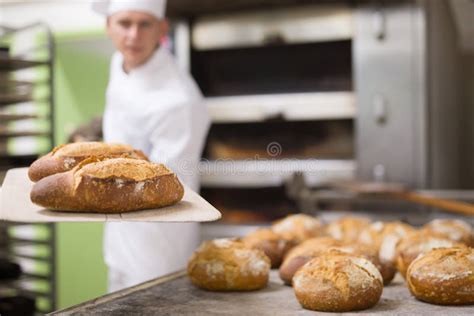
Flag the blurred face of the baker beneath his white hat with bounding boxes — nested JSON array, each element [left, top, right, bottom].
[[107, 11, 168, 70]]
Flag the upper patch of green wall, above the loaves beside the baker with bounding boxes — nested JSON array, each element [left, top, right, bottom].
[[55, 33, 110, 144]]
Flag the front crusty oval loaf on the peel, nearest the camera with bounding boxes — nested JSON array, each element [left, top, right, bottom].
[[30, 158, 184, 213]]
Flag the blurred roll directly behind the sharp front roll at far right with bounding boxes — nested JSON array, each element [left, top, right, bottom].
[[396, 231, 466, 277]]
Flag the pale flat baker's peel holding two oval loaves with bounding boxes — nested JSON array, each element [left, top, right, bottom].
[[0, 168, 221, 222]]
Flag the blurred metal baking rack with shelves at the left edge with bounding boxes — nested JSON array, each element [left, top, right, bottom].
[[0, 23, 56, 314]]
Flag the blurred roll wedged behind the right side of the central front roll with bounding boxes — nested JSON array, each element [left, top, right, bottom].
[[358, 221, 416, 285]]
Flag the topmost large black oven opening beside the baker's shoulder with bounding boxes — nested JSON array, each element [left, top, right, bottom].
[[191, 40, 352, 96]]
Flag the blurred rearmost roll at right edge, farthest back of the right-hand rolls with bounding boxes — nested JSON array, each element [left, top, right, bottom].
[[423, 219, 474, 247]]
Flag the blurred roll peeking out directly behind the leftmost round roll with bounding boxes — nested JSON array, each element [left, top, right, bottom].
[[242, 228, 295, 268]]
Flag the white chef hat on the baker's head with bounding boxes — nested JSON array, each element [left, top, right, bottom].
[[92, 0, 166, 19]]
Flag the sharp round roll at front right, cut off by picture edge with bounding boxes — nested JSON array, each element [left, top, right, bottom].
[[407, 247, 474, 305]]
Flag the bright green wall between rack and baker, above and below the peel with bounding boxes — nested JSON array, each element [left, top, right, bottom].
[[55, 31, 110, 309]]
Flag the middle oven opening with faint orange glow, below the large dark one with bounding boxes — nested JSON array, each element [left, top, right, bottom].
[[204, 120, 355, 160]]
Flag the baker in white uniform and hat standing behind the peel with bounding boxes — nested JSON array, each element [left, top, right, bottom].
[[93, 0, 209, 291]]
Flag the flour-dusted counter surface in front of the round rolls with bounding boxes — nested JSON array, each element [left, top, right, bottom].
[[52, 271, 474, 316]]
